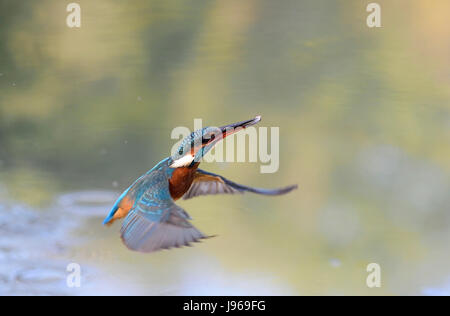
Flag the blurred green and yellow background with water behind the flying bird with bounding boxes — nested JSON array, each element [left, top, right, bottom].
[[0, 0, 450, 295]]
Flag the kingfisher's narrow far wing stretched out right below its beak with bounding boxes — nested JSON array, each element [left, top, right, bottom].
[[183, 169, 297, 200]]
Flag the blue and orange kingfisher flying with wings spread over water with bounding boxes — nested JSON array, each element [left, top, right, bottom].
[[103, 116, 297, 253]]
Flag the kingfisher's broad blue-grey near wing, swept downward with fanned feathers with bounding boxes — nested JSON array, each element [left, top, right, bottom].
[[120, 175, 207, 252]]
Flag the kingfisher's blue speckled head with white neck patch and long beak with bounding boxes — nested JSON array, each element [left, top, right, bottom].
[[170, 115, 261, 168]]
